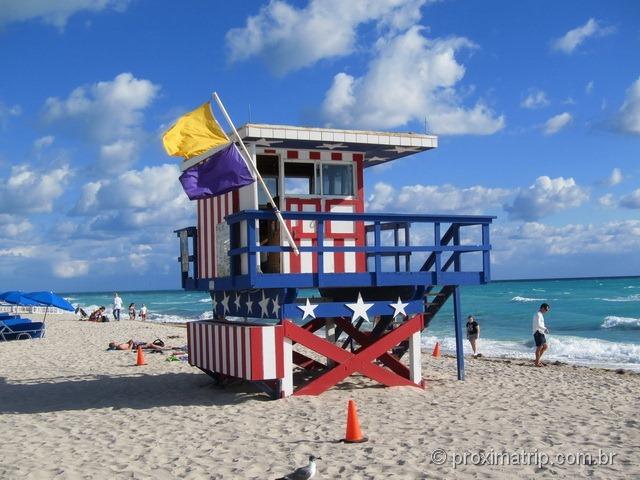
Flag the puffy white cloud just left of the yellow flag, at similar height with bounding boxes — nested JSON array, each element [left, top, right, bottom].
[[42, 73, 160, 144]]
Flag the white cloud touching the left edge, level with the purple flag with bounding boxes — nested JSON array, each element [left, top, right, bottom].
[[0, 165, 71, 214]]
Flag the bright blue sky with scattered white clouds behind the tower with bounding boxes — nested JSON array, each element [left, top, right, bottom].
[[0, 0, 640, 291]]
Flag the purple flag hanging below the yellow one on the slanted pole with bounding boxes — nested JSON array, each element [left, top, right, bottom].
[[180, 143, 254, 200]]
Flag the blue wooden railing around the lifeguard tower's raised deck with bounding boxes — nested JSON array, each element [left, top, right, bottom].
[[178, 210, 495, 290]]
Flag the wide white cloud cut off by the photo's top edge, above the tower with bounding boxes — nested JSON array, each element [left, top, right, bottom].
[[226, 0, 426, 75]]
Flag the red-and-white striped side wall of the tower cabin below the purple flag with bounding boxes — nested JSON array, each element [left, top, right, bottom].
[[196, 190, 239, 278]]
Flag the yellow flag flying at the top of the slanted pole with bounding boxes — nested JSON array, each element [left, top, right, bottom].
[[162, 102, 229, 159]]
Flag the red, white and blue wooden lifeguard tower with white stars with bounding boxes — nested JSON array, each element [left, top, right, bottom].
[[176, 124, 494, 398]]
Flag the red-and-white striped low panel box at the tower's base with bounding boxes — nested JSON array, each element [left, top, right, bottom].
[[187, 321, 284, 380]]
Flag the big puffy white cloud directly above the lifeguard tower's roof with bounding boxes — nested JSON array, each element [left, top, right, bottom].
[[323, 27, 505, 135]]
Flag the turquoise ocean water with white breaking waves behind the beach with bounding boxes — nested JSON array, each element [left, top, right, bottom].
[[65, 277, 640, 371]]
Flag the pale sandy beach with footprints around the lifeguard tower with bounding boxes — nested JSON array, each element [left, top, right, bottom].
[[0, 316, 640, 479]]
